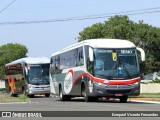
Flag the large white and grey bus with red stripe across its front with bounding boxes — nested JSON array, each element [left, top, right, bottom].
[[49, 39, 145, 103]]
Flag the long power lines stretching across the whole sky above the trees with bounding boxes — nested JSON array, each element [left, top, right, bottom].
[[0, 7, 160, 25]]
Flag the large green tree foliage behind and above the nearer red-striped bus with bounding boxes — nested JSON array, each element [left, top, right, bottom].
[[78, 16, 160, 73]]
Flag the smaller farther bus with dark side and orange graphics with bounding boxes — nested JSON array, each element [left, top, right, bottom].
[[5, 57, 50, 97]]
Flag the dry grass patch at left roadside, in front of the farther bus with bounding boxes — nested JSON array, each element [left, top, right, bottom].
[[0, 95, 30, 103]]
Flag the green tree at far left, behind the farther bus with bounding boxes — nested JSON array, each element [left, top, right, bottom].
[[0, 43, 28, 79]]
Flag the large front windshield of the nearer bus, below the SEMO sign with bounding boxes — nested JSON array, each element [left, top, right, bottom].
[[94, 48, 140, 80]]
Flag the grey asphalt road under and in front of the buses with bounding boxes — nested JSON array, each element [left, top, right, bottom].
[[0, 96, 160, 120]]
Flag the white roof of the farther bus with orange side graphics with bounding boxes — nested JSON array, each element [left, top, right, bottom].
[[6, 57, 50, 66]]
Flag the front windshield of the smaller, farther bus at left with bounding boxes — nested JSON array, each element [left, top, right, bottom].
[[28, 64, 49, 85]]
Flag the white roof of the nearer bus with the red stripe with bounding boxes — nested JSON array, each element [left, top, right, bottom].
[[52, 39, 136, 56]]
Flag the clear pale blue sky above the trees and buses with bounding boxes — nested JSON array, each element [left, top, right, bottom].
[[0, 0, 160, 58]]
